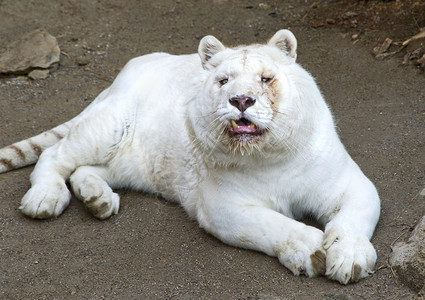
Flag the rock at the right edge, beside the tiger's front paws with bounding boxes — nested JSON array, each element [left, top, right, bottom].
[[390, 216, 425, 293]]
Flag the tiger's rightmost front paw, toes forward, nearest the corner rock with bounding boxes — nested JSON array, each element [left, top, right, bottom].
[[323, 229, 377, 284]]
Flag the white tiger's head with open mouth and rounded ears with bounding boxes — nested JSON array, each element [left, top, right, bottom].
[[192, 30, 320, 163]]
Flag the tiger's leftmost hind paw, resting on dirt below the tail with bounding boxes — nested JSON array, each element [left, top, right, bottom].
[[19, 182, 71, 219]]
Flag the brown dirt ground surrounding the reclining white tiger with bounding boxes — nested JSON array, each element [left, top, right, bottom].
[[0, 0, 425, 299]]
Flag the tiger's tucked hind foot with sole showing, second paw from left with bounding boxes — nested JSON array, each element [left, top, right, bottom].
[[70, 166, 120, 219]]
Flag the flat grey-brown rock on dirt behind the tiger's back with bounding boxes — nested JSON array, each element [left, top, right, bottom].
[[0, 29, 60, 74]]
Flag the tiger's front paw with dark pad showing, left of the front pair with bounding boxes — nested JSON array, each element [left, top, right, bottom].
[[278, 226, 326, 277]]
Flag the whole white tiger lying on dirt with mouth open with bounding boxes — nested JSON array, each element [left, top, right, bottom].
[[0, 30, 380, 284]]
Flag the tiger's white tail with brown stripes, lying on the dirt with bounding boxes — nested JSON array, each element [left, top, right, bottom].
[[0, 120, 73, 173]]
